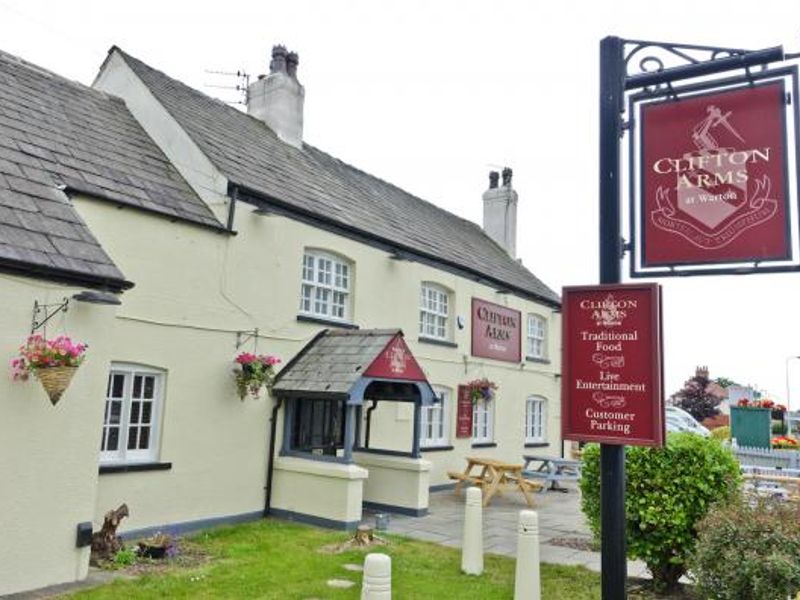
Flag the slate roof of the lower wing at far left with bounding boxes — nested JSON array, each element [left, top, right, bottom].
[[0, 52, 221, 290]]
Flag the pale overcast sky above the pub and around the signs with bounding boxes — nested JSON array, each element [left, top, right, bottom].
[[0, 0, 800, 407]]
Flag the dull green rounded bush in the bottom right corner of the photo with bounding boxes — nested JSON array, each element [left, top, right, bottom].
[[690, 500, 800, 600]]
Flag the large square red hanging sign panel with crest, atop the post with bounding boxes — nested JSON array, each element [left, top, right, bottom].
[[641, 81, 791, 267]]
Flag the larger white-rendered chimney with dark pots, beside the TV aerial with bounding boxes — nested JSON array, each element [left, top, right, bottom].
[[247, 46, 305, 148]]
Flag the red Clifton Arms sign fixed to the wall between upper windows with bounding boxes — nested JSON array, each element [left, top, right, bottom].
[[472, 298, 522, 362]]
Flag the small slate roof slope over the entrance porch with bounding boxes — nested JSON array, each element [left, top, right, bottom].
[[272, 329, 400, 395]]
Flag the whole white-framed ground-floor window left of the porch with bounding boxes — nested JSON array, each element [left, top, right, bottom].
[[100, 363, 164, 463]]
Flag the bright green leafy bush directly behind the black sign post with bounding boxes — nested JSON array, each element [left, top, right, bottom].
[[580, 433, 740, 591]]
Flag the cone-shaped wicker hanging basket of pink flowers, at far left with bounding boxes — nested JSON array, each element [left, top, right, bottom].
[[11, 335, 86, 406]]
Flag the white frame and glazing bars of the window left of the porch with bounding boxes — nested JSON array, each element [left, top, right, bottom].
[[100, 363, 166, 464]]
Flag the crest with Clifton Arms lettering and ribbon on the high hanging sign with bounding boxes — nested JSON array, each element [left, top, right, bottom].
[[650, 104, 778, 250]]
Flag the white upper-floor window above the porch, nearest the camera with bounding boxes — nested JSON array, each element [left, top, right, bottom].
[[300, 250, 352, 321]]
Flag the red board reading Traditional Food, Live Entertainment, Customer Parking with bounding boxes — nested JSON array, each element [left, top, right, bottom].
[[561, 284, 664, 446]]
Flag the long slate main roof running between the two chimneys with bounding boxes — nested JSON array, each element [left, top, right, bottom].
[[110, 47, 560, 305]]
